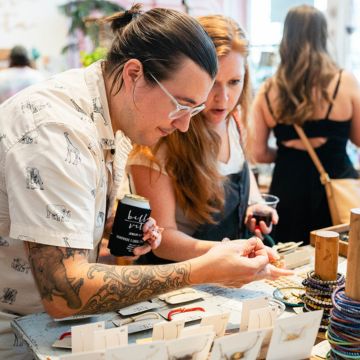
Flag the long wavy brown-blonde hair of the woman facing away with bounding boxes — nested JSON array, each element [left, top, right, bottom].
[[265, 5, 338, 125]]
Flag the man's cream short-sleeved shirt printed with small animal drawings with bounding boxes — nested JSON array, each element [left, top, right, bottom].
[[0, 63, 132, 317]]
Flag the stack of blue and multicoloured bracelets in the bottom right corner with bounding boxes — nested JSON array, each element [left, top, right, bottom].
[[326, 286, 360, 359]]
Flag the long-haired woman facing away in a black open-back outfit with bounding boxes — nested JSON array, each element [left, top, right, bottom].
[[253, 5, 360, 243]]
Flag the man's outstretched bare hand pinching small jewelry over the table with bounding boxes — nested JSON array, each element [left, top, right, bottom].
[[200, 237, 293, 287]]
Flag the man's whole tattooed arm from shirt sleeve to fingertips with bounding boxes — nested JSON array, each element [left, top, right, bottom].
[[27, 239, 292, 318]]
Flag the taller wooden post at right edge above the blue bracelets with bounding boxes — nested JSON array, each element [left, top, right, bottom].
[[345, 208, 360, 301]]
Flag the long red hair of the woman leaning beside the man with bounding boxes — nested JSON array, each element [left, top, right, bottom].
[[130, 15, 251, 224]]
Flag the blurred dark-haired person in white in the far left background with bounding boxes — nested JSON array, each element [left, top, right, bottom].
[[0, 45, 44, 104]]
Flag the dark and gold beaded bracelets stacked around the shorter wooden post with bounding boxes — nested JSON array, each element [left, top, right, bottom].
[[301, 271, 345, 331]]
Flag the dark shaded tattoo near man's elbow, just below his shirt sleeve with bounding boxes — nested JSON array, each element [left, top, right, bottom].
[[28, 243, 89, 309]]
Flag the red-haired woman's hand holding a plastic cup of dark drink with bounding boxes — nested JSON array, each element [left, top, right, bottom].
[[244, 204, 279, 239]]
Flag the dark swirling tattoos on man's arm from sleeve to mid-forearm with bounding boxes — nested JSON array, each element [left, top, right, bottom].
[[27, 243, 191, 314]]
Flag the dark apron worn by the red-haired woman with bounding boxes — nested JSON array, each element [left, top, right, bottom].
[[136, 162, 250, 265]]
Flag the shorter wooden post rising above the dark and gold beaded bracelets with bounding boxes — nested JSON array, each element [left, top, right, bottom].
[[315, 230, 339, 281]]
